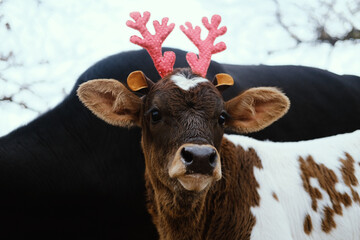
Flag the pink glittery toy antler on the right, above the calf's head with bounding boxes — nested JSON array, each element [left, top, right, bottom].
[[180, 15, 227, 77]]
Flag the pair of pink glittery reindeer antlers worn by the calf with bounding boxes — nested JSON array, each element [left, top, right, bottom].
[[126, 12, 226, 77]]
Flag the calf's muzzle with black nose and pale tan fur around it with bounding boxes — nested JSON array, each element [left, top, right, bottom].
[[169, 143, 221, 191]]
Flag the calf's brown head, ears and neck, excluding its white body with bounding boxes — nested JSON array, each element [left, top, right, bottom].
[[78, 69, 289, 239]]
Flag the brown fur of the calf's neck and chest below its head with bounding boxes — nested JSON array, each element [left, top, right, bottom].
[[146, 139, 262, 239]]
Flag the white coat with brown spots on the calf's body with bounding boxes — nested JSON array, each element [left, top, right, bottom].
[[225, 131, 360, 240]]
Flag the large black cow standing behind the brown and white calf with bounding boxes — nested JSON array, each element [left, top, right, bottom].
[[0, 49, 360, 239]]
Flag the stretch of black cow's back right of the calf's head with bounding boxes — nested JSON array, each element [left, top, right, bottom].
[[222, 64, 360, 141]]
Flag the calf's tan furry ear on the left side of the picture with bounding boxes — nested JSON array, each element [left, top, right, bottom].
[[77, 79, 142, 127]]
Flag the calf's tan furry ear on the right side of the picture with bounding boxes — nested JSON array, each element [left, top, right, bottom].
[[225, 87, 290, 133]]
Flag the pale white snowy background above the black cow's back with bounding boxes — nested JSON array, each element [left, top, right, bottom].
[[0, 0, 360, 136]]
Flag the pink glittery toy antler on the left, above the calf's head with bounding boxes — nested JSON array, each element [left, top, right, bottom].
[[126, 12, 175, 77]]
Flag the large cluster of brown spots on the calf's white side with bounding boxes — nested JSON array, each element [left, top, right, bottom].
[[299, 153, 359, 233]]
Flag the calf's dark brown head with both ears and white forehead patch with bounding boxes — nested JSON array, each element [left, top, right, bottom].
[[78, 69, 289, 192]]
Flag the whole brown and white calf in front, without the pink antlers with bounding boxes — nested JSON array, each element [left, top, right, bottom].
[[78, 69, 360, 240]]
